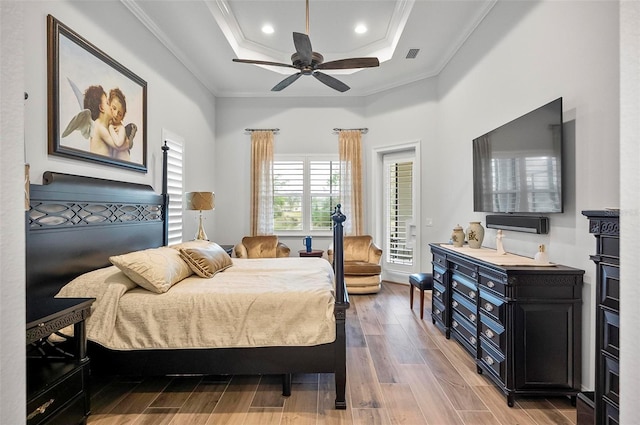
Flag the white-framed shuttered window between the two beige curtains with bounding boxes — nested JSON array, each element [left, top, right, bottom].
[[273, 157, 340, 233]]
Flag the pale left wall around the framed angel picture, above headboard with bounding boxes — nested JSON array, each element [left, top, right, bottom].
[[24, 1, 215, 242]]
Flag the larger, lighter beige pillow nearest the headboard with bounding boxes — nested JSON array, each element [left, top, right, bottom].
[[109, 247, 193, 294]]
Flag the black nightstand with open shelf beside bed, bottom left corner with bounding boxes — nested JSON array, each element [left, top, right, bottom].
[[26, 298, 94, 425]]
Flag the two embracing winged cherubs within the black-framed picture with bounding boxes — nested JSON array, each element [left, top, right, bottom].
[[62, 78, 137, 161]]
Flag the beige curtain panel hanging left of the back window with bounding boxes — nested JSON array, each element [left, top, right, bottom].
[[251, 130, 273, 236]]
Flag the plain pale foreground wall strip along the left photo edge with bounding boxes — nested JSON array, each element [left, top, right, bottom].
[[0, 1, 27, 424]]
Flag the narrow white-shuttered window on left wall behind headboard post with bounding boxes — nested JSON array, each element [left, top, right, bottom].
[[163, 131, 184, 245]]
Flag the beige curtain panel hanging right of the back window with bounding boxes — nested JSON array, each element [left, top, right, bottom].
[[338, 130, 363, 235]]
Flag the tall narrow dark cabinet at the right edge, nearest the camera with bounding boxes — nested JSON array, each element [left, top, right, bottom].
[[582, 210, 620, 424]]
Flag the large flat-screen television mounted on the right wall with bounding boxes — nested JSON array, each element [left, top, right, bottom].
[[473, 97, 563, 214]]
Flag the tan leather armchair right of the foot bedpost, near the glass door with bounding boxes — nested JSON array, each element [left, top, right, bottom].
[[327, 235, 382, 294]]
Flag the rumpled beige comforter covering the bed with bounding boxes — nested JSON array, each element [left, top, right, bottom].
[[57, 257, 335, 350]]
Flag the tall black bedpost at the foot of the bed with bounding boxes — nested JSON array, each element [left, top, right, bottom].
[[331, 204, 349, 409]]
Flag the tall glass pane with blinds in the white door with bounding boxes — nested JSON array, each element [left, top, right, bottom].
[[385, 157, 413, 266]]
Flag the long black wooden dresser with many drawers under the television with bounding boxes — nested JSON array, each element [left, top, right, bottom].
[[430, 244, 584, 406]]
